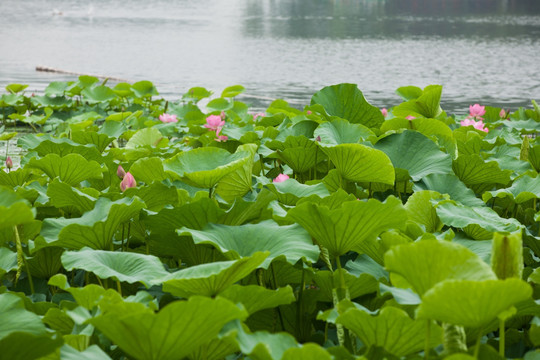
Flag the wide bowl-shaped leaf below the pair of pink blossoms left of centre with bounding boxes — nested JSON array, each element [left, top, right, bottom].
[[163, 147, 251, 189]]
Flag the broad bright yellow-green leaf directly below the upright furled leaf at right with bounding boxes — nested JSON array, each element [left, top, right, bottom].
[[416, 278, 532, 328]]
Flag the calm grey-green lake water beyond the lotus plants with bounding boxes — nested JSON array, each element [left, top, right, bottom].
[[0, 0, 540, 112]]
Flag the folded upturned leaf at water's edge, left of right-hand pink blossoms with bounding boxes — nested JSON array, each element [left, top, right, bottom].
[[392, 85, 443, 118]]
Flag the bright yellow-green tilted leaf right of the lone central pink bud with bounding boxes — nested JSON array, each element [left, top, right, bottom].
[[322, 144, 395, 185]]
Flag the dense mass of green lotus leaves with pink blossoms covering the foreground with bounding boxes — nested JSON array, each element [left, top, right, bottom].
[[0, 76, 540, 360]]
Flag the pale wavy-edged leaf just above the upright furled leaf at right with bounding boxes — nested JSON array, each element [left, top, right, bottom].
[[437, 202, 522, 240]]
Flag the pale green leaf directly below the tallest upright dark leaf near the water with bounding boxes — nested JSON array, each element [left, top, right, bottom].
[[313, 118, 375, 146]]
